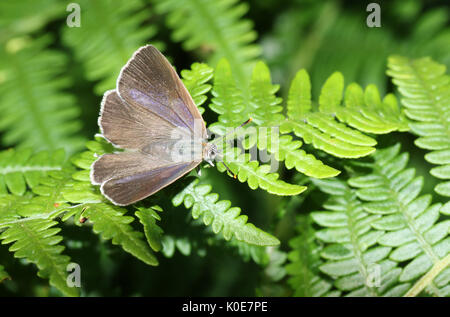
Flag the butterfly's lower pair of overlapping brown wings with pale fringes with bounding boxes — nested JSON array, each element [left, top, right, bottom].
[[91, 152, 200, 206]]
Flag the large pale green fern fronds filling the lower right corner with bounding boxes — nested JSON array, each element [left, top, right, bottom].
[[298, 144, 450, 296]]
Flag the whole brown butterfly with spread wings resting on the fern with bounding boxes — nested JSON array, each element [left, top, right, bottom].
[[90, 45, 218, 206]]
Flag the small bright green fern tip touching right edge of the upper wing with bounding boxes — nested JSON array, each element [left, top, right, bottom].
[[181, 63, 214, 114]]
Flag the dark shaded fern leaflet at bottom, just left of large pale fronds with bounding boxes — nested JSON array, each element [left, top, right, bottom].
[[285, 216, 340, 297]]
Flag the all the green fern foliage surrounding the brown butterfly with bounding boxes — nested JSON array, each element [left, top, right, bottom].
[[0, 0, 450, 296]]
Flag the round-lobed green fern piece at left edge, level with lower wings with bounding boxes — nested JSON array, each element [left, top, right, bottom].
[[0, 149, 65, 195]]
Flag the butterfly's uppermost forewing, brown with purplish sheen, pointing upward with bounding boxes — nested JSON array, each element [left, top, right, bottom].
[[117, 45, 207, 142]]
